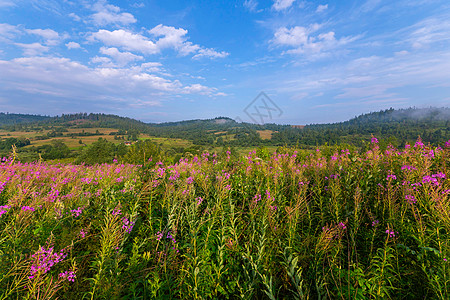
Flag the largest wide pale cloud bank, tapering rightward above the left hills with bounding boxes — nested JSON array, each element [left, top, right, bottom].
[[0, 56, 217, 103]]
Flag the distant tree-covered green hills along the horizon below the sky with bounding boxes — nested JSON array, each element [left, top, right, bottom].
[[0, 108, 450, 156]]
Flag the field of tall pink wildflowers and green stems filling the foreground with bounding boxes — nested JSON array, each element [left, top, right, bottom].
[[0, 138, 450, 299]]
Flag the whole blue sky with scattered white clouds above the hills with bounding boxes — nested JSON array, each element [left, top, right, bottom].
[[0, 0, 450, 124]]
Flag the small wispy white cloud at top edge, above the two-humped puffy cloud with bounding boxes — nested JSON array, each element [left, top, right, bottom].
[[90, 0, 137, 26]]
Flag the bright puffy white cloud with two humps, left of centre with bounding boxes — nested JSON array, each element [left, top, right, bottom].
[[88, 24, 229, 58]]
